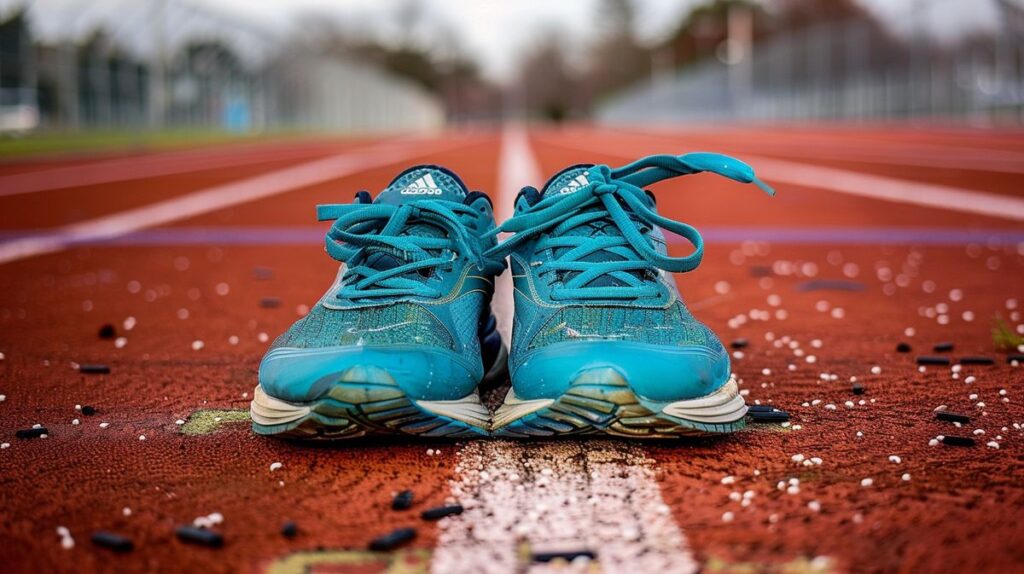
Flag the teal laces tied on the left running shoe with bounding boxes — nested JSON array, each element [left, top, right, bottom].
[[316, 201, 504, 299]]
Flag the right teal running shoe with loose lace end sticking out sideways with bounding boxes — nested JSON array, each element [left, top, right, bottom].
[[488, 153, 774, 438]]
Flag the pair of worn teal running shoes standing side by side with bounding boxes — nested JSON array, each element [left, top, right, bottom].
[[251, 153, 773, 439]]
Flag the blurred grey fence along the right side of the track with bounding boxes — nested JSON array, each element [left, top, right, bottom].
[[598, 0, 1024, 124]]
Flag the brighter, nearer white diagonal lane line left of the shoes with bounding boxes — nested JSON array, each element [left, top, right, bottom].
[[0, 141, 475, 265]]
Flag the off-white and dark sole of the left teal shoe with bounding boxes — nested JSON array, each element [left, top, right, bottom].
[[249, 347, 507, 440]]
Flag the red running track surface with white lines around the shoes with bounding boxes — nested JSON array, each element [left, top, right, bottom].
[[0, 126, 1024, 572]]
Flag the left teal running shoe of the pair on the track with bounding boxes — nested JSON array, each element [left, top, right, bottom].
[[250, 166, 507, 439]]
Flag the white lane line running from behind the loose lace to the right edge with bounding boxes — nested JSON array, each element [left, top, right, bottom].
[[540, 135, 1024, 221]]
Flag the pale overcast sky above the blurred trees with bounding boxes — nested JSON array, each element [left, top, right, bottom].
[[0, 0, 1007, 80]]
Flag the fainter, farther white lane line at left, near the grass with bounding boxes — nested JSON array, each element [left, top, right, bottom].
[[0, 140, 358, 197]]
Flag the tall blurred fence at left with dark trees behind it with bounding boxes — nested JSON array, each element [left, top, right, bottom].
[[0, 0, 444, 132]]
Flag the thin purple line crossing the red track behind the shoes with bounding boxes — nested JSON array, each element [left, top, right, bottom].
[[0, 225, 1024, 247]]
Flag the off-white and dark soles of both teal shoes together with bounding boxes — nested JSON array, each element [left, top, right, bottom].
[[250, 348, 746, 440]]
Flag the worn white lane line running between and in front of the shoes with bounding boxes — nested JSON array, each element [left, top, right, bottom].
[[431, 127, 697, 574]]
